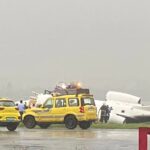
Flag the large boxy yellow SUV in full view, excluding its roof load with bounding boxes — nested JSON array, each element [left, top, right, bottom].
[[23, 94, 97, 129]]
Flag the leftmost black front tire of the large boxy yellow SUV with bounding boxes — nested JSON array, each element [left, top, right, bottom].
[[23, 116, 36, 129]]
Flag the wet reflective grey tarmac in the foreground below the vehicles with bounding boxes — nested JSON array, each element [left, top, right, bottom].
[[0, 127, 141, 150]]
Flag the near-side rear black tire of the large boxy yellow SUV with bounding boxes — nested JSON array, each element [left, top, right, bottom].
[[65, 115, 77, 129]]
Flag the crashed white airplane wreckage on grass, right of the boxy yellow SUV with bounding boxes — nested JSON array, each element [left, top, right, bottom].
[[95, 91, 150, 124]]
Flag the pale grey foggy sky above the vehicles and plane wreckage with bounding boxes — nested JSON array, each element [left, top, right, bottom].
[[0, 0, 150, 103]]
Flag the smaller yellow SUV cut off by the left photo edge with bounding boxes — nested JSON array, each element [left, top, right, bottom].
[[0, 98, 20, 131]]
